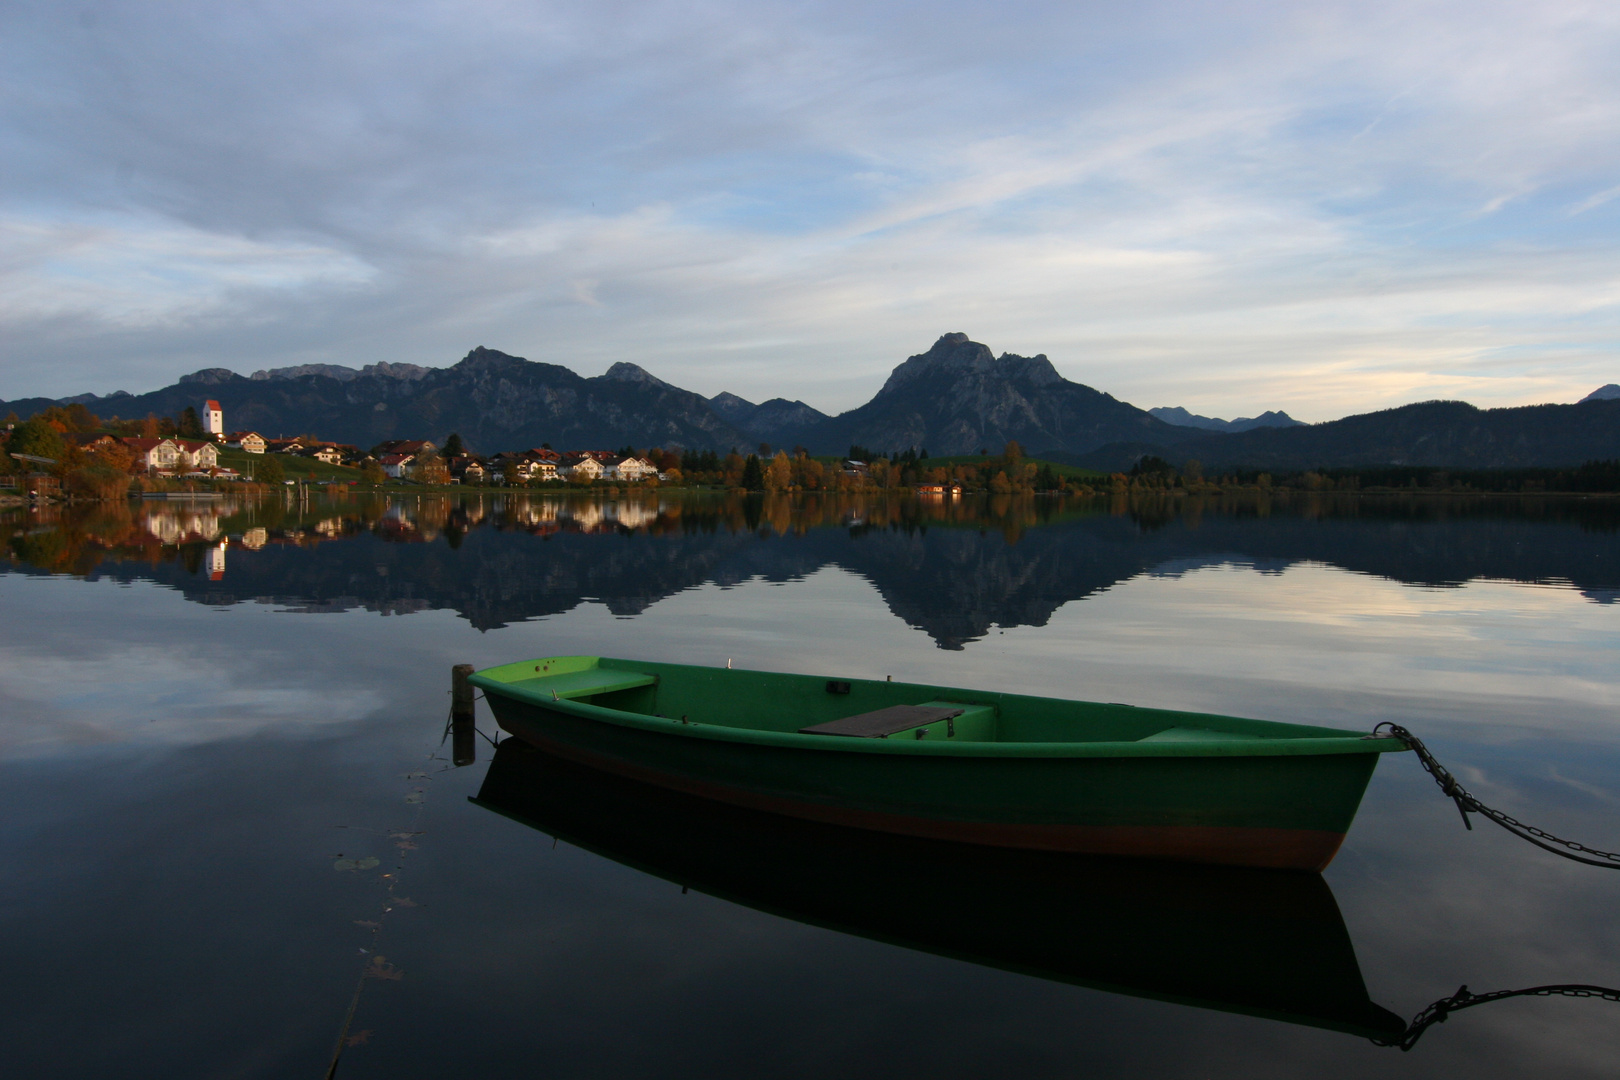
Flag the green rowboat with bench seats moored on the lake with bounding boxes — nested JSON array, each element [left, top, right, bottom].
[[471, 656, 1405, 871]]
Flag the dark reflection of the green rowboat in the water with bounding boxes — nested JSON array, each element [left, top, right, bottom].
[[475, 740, 1406, 1038]]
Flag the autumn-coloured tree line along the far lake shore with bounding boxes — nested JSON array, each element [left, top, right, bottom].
[[0, 405, 1620, 500]]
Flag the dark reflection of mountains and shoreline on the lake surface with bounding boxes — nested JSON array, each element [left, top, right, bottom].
[[10, 497, 1620, 648]]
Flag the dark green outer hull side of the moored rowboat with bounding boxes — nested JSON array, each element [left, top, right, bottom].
[[475, 672, 1377, 871]]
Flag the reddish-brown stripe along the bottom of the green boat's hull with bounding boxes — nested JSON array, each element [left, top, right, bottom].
[[498, 732, 1345, 871]]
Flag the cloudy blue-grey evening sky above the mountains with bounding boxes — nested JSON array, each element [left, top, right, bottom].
[[0, 0, 1620, 421]]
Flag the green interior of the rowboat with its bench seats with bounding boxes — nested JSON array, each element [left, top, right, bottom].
[[481, 656, 1359, 743]]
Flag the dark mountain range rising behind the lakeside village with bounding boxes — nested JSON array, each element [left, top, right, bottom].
[[0, 334, 1620, 470]]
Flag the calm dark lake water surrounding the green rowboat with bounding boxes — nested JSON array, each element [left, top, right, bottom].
[[0, 495, 1620, 1078]]
